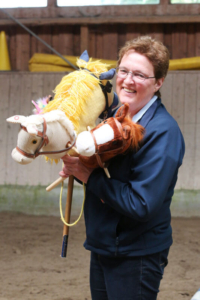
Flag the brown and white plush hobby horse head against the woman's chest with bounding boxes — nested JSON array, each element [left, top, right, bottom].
[[76, 103, 144, 168]]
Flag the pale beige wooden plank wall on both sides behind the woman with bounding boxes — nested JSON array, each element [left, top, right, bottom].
[[0, 71, 200, 189]]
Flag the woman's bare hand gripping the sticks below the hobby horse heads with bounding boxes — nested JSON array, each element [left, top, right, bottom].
[[59, 155, 94, 183]]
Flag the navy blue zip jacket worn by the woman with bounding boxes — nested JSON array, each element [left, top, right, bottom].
[[84, 99, 185, 256]]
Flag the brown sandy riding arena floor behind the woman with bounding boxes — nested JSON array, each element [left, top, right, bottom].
[[0, 212, 200, 300]]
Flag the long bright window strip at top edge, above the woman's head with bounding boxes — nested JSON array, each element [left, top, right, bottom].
[[57, 0, 160, 6]]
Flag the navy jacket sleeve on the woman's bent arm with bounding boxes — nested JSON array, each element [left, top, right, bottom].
[[87, 122, 184, 222]]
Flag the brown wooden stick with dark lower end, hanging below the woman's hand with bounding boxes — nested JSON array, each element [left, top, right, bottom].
[[61, 175, 74, 257]]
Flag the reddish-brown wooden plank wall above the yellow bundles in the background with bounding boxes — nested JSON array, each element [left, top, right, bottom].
[[3, 23, 200, 71]]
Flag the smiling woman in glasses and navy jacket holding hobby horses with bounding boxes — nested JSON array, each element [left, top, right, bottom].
[[60, 36, 184, 300]]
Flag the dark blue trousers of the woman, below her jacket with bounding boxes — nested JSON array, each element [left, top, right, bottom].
[[90, 249, 169, 300]]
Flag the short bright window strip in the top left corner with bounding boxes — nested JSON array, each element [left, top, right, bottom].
[[0, 0, 47, 8]]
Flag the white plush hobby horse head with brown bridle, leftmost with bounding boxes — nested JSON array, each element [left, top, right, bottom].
[[7, 110, 75, 164]]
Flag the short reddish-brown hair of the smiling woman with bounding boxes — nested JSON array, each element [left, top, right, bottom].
[[117, 36, 169, 97]]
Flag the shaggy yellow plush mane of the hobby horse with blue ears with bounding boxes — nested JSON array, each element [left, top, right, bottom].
[[42, 59, 113, 133]]
